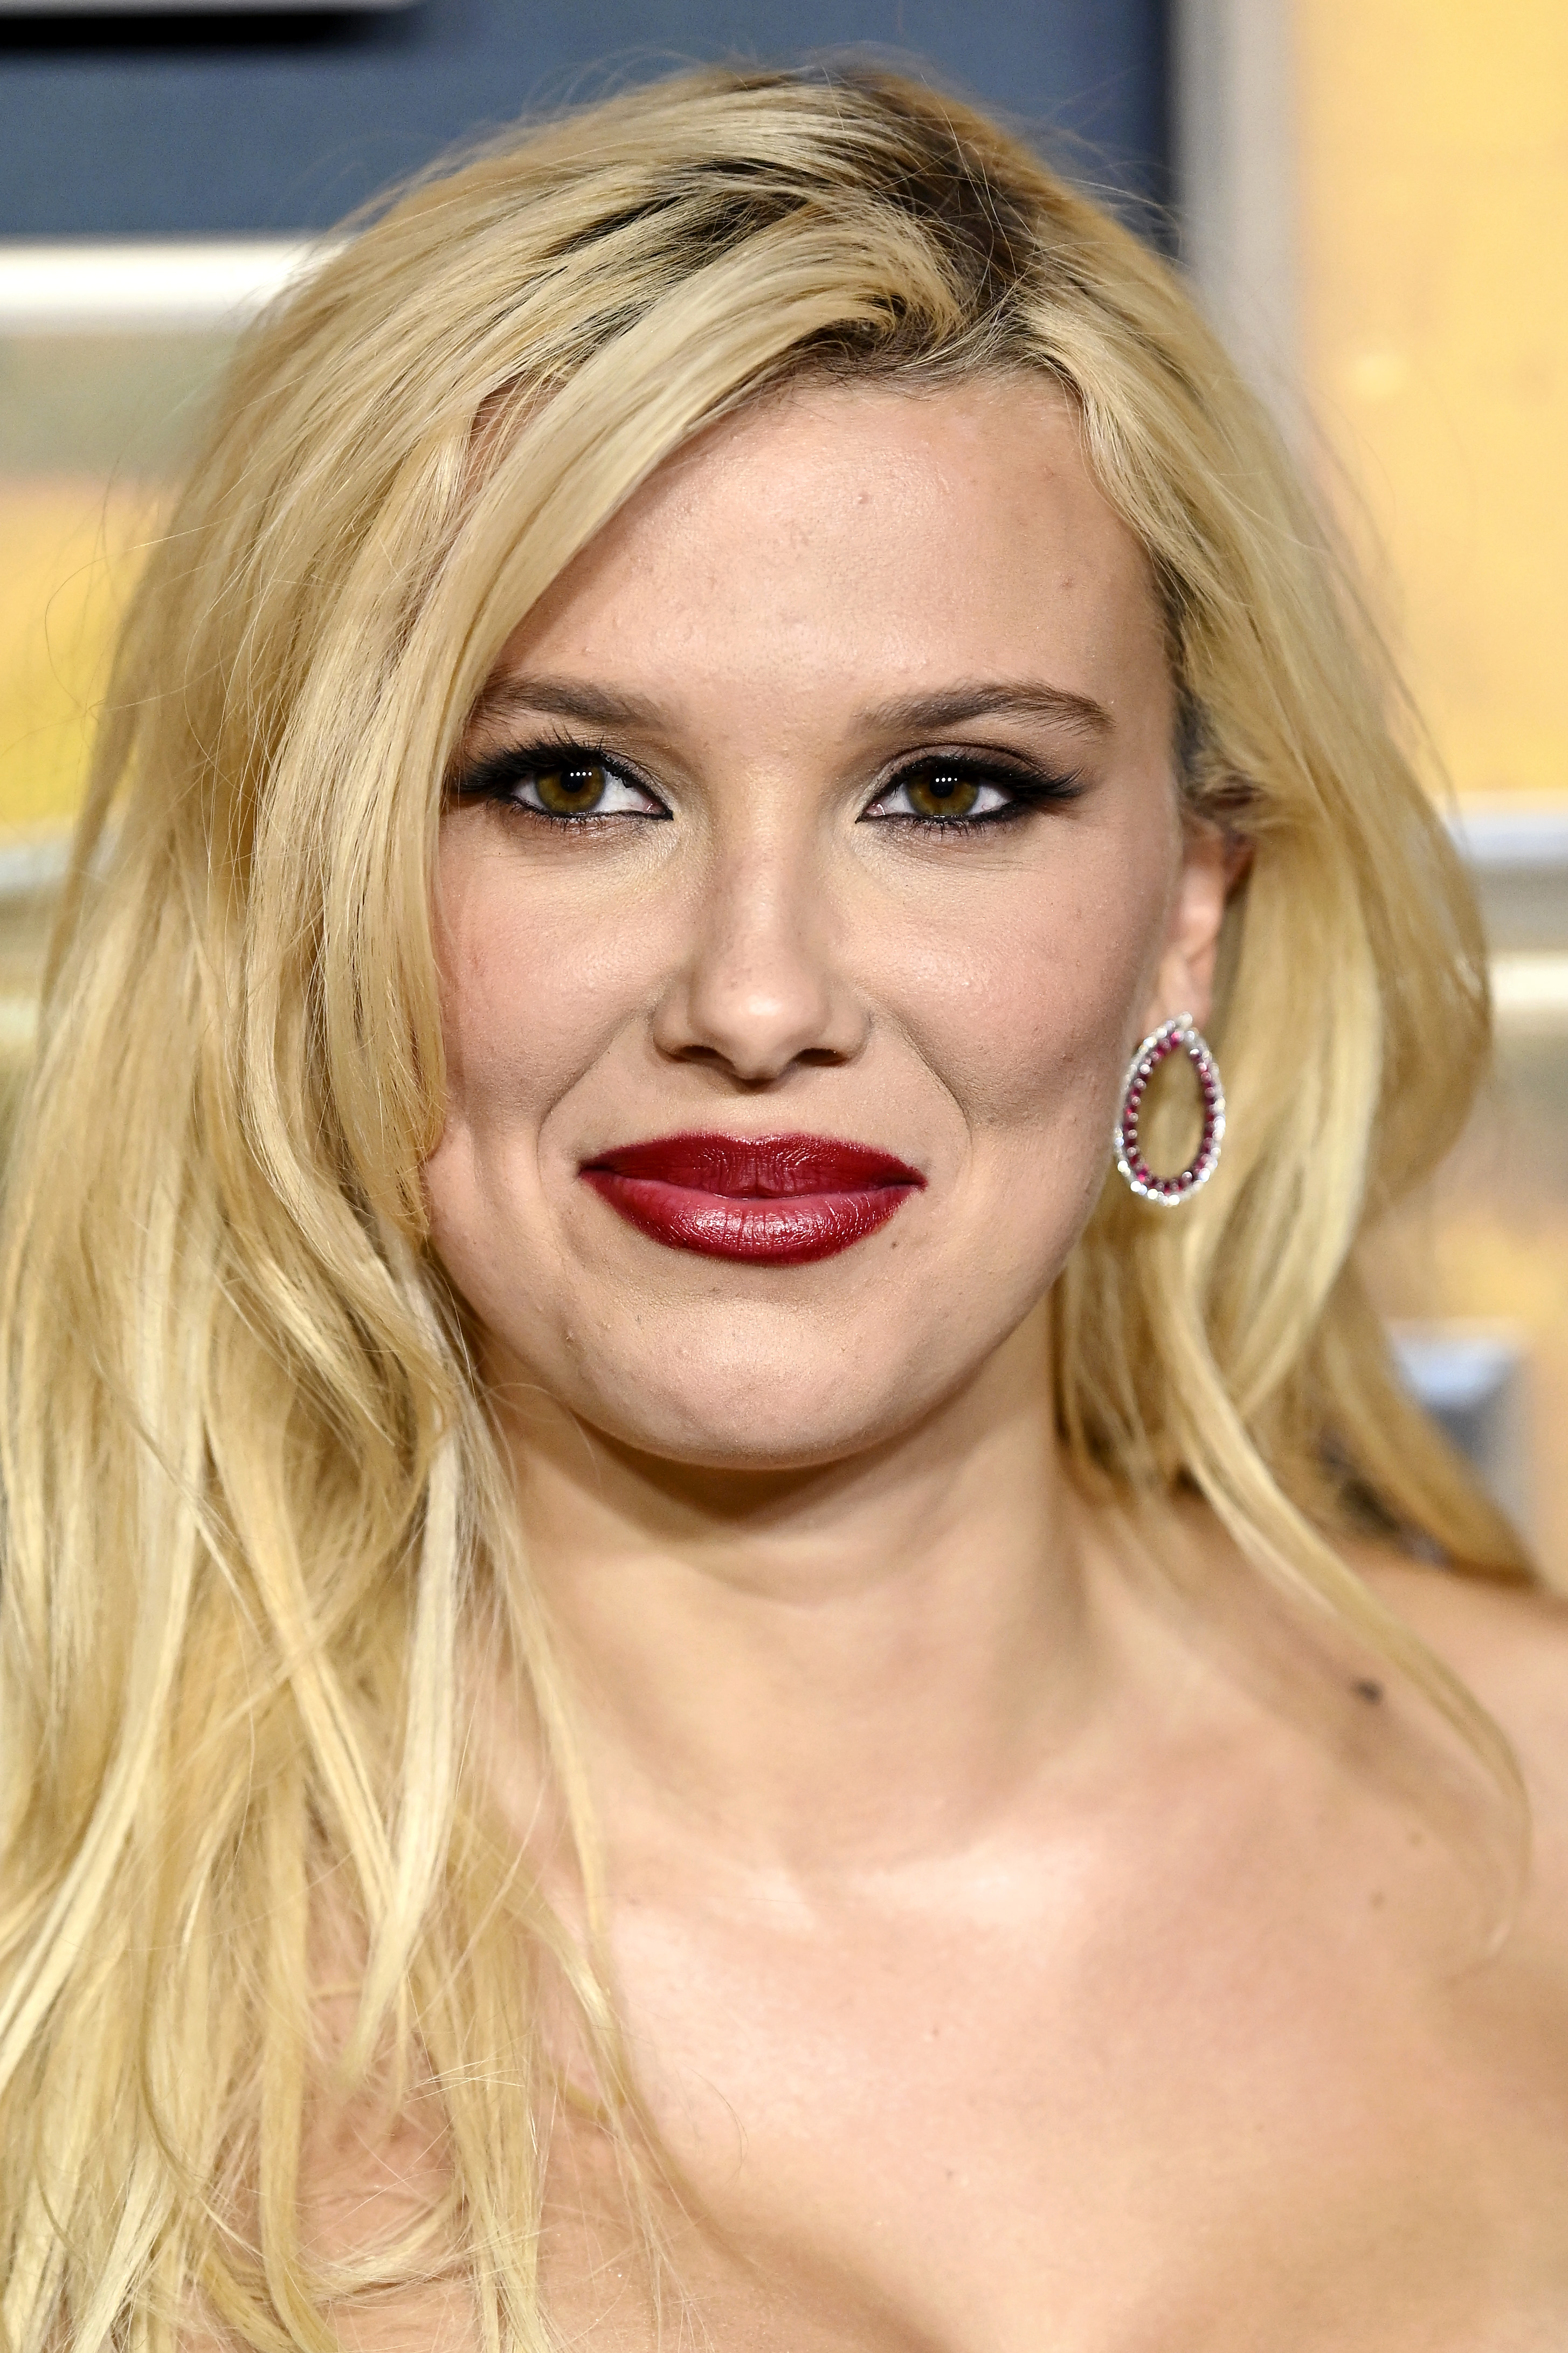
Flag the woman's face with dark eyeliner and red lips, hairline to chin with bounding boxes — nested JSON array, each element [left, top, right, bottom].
[[425, 379, 1222, 1468]]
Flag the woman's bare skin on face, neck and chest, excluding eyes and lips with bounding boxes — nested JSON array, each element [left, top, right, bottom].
[[308, 379, 1568, 2353]]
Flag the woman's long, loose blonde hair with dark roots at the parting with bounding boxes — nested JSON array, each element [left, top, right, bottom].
[[0, 71, 1525, 2353]]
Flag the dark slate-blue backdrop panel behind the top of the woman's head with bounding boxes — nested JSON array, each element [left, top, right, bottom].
[[0, 0, 1171, 238]]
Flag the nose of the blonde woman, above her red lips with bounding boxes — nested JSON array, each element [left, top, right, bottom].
[[653, 840, 870, 1087]]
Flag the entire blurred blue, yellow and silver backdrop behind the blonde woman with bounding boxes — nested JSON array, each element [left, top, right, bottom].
[[0, 0, 1568, 1586]]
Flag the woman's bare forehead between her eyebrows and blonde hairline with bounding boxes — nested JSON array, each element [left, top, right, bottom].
[[501, 376, 1166, 706]]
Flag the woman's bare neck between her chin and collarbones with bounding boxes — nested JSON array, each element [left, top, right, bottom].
[[484, 1311, 1095, 1870]]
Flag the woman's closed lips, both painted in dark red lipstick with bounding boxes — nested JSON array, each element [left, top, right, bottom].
[[581, 1134, 926, 1266]]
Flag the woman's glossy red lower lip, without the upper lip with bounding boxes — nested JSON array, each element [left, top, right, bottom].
[[583, 1143, 922, 1266]]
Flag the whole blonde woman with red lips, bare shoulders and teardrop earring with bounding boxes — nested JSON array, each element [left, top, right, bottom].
[[0, 59, 1568, 2353]]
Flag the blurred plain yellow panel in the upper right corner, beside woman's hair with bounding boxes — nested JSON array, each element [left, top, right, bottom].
[[1297, 0, 1568, 795]]
